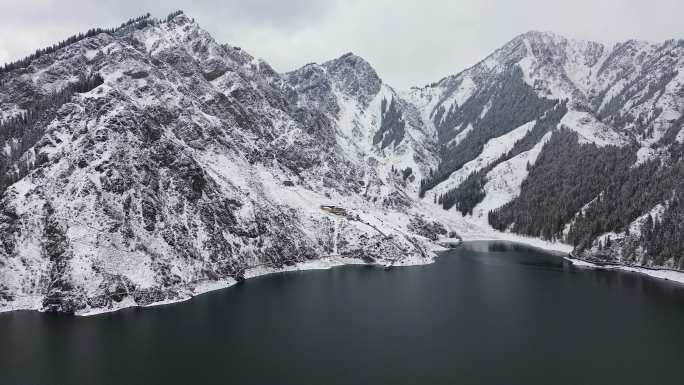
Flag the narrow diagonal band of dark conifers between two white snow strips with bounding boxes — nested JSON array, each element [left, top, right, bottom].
[[437, 100, 568, 215]]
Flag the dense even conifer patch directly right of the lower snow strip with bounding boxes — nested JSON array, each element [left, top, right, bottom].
[[489, 128, 636, 240]]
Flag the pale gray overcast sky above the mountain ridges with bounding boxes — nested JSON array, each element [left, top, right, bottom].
[[0, 0, 684, 88]]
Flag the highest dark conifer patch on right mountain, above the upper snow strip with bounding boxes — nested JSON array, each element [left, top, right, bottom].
[[419, 66, 556, 198]]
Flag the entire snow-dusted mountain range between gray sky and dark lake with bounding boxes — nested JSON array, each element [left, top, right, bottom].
[[0, 11, 684, 314]]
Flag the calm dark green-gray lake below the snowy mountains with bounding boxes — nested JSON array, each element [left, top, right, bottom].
[[0, 242, 684, 385]]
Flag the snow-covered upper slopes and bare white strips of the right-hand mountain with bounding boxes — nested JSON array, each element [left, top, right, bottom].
[[407, 31, 684, 270]]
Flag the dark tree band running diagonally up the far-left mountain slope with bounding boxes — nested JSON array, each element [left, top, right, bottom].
[[0, 74, 104, 193]]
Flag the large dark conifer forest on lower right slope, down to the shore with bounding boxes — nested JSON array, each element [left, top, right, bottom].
[[489, 129, 684, 265]]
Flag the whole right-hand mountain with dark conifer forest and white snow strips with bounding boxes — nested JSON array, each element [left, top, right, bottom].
[[408, 32, 684, 268]]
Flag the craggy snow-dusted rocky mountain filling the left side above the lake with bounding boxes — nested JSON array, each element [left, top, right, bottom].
[[0, 14, 434, 313]]
